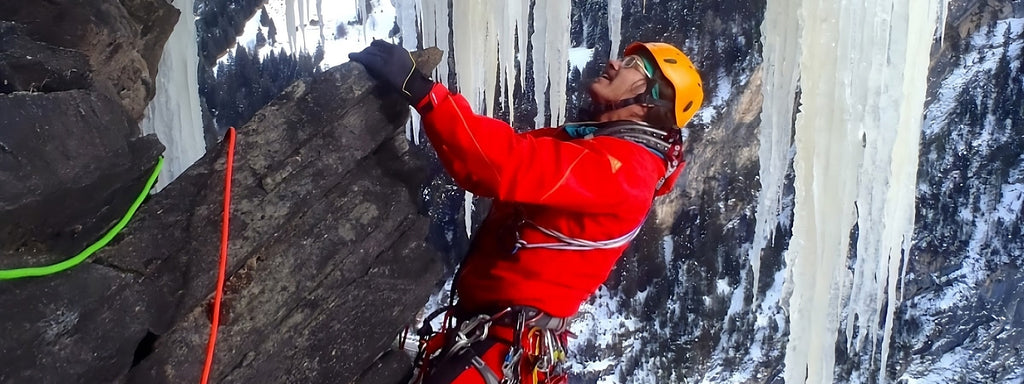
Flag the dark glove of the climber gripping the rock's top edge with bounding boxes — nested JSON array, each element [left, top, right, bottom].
[[348, 40, 434, 104]]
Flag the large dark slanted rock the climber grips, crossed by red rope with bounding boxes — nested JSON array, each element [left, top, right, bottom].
[[0, 50, 448, 383]]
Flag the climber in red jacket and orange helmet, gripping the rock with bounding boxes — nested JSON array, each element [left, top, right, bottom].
[[349, 41, 703, 384]]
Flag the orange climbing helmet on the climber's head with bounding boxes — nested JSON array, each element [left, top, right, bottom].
[[624, 42, 703, 128]]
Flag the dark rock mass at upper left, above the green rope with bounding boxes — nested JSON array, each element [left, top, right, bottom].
[[0, 0, 178, 274]]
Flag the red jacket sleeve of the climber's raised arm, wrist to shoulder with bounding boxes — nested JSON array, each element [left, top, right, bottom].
[[418, 84, 665, 212]]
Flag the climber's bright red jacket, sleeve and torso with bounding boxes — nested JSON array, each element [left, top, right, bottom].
[[418, 84, 682, 317]]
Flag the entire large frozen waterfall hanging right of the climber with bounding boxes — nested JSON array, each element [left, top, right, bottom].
[[751, 0, 946, 383]]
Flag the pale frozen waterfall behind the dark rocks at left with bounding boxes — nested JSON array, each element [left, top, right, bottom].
[[141, 0, 206, 190]]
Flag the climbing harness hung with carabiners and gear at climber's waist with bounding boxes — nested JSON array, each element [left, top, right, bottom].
[[416, 306, 571, 384]]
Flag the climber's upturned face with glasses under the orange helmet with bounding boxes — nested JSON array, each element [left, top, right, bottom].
[[590, 56, 647, 103]]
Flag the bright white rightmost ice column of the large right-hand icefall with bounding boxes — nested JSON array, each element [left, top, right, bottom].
[[846, 0, 946, 383]]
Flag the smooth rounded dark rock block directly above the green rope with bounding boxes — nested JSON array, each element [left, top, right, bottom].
[[0, 90, 163, 268]]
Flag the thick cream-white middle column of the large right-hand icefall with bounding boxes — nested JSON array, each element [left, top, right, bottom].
[[784, 0, 862, 384]]
